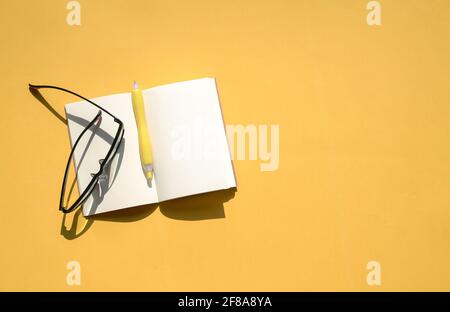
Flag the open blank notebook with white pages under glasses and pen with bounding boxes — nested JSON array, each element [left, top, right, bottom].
[[65, 78, 236, 216]]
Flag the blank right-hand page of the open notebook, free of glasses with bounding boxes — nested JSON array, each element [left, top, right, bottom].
[[143, 78, 236, 201]]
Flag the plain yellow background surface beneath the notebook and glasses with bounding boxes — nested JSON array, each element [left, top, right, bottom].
[[0, 0, 450, 291]]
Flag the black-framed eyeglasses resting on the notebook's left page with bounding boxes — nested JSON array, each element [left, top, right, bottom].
[[28, 84, 125, 213]]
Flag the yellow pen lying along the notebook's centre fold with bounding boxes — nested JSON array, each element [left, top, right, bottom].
[[131, 81, 153, 186]]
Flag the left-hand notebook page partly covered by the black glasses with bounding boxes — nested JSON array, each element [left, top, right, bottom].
[[65, 93, 158, 216]]
